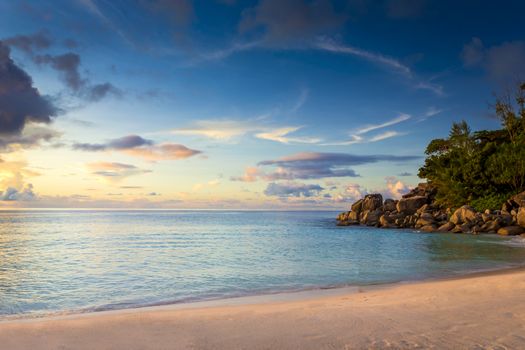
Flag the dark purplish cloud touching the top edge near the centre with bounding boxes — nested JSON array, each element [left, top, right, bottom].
[[239, 0, 345, 45]]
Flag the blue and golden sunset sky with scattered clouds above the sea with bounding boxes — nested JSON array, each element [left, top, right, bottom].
[[0, 0, 525, 210]]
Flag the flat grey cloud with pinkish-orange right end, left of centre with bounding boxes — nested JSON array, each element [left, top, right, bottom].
[[72, 135, 202, 161]]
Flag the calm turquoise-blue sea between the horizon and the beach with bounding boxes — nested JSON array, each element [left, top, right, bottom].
[[0, 211, 525, 317]]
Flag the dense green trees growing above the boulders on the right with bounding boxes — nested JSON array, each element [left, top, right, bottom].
[[418, 84, 525, 210]]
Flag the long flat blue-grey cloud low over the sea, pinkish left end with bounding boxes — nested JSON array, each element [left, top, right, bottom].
[[231, 152, 420, 182]]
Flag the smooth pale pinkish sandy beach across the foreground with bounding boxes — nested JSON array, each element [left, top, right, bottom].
[[0, 269, 525, 350]]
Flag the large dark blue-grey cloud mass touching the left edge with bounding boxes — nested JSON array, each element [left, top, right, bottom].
[[0, 41, 59, 135]]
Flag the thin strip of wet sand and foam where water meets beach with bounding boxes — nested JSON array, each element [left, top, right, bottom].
[[4, 262, 525, 327]]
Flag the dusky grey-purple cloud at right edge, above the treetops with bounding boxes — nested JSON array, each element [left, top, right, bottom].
[[461, 38, 525, 83]]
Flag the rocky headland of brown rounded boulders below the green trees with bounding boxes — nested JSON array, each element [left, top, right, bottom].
[[337, 183, 525, 236]]
